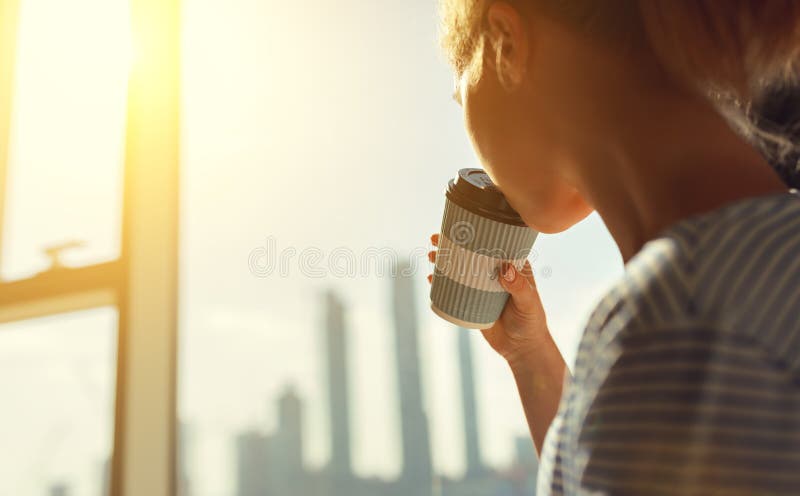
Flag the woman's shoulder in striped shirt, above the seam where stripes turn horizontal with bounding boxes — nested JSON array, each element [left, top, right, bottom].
[[582, 189, 800, 376]]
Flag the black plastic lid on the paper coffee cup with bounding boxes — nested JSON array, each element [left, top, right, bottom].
[[446, 169, 526, 226]]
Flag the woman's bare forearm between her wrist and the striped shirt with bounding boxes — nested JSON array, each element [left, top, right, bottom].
[[509, 333, 566, 454]]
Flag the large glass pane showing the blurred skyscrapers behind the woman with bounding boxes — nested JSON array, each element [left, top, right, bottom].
[[179, 0, 621, 496]]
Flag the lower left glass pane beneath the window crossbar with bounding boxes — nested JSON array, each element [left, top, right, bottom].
[[0, 308, 117, 496]]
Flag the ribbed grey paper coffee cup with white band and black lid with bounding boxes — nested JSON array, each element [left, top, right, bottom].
[[430, 169, 538, 329]]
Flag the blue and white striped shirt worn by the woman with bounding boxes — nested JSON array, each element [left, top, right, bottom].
[[537, 190, 800, 496]]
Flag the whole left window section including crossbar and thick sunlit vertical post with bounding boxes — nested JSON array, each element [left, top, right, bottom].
[[0, 0, 179, 496]]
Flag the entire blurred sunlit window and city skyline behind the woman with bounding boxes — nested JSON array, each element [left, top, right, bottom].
[[0, 0, 622, 496]]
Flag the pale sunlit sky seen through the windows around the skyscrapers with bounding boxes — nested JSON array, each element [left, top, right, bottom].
[[0, 0, 622, 496]]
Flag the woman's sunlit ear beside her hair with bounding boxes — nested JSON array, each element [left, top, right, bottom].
[[484, 2, 529, 91]]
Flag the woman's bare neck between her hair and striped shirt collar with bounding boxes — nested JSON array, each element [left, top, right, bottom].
[[571, 86, 787, 262]]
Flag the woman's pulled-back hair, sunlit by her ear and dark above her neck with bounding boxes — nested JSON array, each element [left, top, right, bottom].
[[441, 0, 800, 184]]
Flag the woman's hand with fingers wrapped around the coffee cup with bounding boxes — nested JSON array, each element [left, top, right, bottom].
[[428, 234, 552, 368]]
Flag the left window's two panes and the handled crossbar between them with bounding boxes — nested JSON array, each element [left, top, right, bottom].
[[0, 0, 128, 495]]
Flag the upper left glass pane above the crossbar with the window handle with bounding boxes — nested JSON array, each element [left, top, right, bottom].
[[0, 0, 130, 279]]
